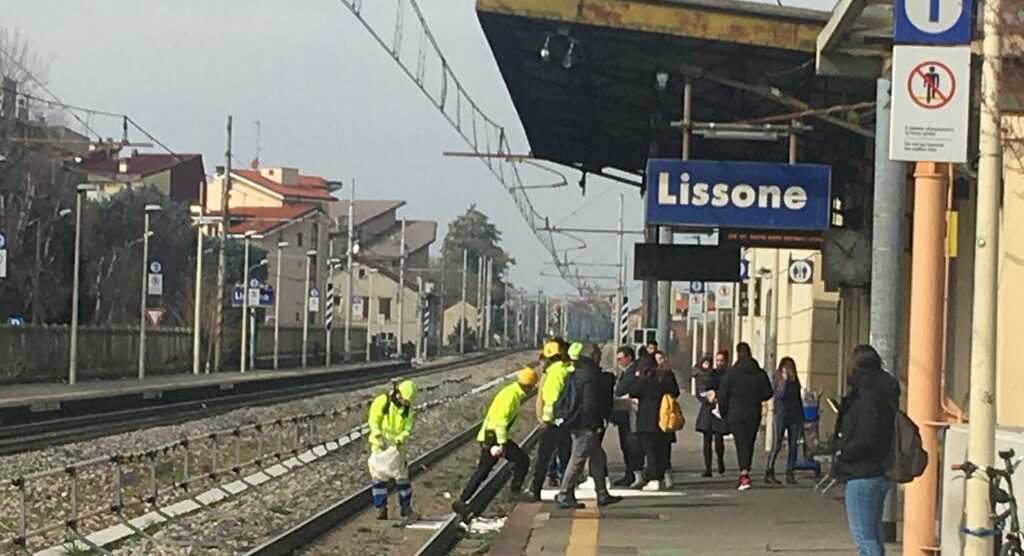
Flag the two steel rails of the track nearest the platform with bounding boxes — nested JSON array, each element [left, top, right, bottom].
[[246, 424, 540, 556]]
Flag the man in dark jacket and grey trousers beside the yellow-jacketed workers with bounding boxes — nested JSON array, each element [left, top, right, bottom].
[[555, 344, 621, 509]]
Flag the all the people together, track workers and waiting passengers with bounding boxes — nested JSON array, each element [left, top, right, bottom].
[[369, 338, 899, 556]]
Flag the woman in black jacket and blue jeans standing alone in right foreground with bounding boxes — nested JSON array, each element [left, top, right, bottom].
[[833, 345, 899, 556]]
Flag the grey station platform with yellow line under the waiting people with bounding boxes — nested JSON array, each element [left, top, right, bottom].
[[488, 401, 899, 556]]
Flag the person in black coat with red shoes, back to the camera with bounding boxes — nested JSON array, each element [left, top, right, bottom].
[[718, 342, 772, 490]]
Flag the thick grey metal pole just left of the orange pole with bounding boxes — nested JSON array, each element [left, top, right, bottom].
[[868, 79, 906, 542]]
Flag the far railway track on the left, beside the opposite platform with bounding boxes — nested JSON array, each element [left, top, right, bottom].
[[0, 351, 509, 456]]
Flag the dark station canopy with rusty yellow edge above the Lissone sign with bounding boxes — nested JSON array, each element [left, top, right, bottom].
[[477, 0, 874, 193]]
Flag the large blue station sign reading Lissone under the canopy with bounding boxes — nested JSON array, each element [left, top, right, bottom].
[[647, 159, 831, 230]]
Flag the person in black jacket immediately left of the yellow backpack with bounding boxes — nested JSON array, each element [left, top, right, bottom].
[[628, 356, 679, 490]]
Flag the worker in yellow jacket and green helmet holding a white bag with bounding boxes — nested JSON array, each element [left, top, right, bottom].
[[368, 380, 416, 519]]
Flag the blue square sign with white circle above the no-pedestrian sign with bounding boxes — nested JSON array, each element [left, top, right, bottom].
[[893, 0, 972, 44]]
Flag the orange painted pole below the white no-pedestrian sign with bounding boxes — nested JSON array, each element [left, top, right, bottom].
[[903, 162, 949, 556]]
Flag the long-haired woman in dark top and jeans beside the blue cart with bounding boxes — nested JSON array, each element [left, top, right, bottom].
[[765, 357, 804, 484]]
